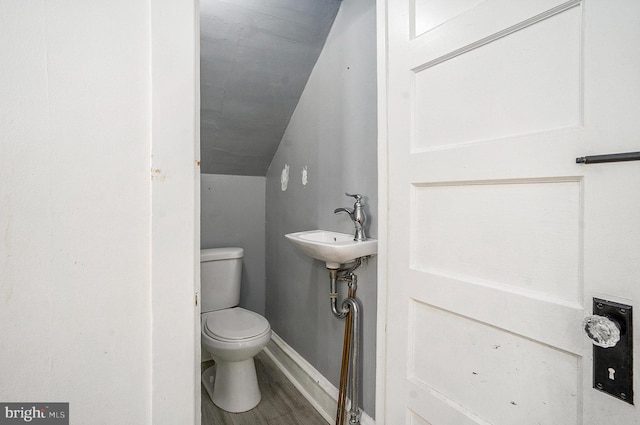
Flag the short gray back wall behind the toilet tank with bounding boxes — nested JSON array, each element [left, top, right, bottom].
[[200, 174, 265, 314]]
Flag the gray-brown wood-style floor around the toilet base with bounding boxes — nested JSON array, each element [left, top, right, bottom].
[[202, 351, 327, 425]]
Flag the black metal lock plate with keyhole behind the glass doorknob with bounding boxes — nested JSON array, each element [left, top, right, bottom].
[[593, 298, 633, 404]]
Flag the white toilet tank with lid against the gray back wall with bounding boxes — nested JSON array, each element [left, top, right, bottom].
[[200, 248, 244, 313]]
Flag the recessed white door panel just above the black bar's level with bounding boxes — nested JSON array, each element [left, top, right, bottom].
[[412, 7, 581, 152]]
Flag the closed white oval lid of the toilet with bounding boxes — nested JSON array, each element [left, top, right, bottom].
[[204, 307, 270, 341]]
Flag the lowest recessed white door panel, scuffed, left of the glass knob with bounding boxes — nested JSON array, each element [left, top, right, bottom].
[[408, 301, 580, 425]]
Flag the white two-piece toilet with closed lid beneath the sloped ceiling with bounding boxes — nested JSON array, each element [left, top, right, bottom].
[[200, 248, 271, 413]]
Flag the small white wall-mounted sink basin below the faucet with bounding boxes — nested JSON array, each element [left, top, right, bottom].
[[284, 230, 378, 269]]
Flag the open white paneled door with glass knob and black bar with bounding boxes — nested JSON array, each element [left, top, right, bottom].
[[377, 0, 640, 425]]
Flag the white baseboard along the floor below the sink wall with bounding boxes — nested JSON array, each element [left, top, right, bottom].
[[264, 332, 375, 425]]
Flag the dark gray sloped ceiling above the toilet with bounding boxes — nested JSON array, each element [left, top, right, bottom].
[[200, 0, 340, 176]]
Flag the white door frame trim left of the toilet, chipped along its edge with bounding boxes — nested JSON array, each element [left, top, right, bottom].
[[150, 0, 201, 425]]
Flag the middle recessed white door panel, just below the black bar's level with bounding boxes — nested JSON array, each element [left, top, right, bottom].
[[410, 180, 582, 302]]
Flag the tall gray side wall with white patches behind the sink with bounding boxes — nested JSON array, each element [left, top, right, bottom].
[[266, 0, 377, 416]]
